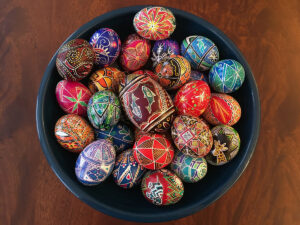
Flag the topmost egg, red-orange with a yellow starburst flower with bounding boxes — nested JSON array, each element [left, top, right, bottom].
[[133, 6, 176, 40]]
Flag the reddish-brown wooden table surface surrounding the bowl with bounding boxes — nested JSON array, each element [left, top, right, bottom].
[[0, 0, 300, 225]]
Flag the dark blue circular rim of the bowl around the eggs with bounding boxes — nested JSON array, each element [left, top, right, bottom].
[[36, 5, 261, 222]]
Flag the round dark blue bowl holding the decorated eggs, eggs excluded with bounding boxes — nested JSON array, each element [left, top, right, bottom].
[[36, 6, 260, 222]]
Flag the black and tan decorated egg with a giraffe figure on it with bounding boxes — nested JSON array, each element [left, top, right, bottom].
[[205, 125, 241, 166]]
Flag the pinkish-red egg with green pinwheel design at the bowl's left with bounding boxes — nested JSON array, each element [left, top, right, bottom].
[[55, 80, 92, 116]]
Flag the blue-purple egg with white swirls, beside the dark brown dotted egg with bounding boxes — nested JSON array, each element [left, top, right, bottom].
[[90, 28, 121, 67]]
